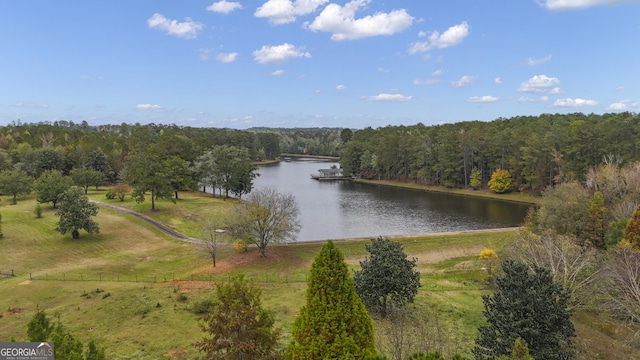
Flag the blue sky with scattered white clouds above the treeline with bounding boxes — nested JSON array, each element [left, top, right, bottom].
[[0, 0, 640, 129]]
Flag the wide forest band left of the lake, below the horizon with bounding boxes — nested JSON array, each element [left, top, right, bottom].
[[0, 120, 280, 182]]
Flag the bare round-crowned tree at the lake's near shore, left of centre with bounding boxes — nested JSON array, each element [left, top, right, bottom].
[[227, 188, 300, 257]]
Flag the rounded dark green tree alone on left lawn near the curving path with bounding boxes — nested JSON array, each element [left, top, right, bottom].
[[56, 187, 100, 239]]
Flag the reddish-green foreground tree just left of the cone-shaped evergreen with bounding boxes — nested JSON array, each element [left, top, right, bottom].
[[194, 276, 279, 360]]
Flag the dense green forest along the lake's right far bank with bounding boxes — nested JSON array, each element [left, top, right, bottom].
[[340, 112, 640, 193]]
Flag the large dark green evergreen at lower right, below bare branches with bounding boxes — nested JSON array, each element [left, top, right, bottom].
[[473, 260, 575, 360]]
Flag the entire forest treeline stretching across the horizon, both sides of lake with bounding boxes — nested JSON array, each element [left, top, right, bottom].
[[5, 112, 640, 197]]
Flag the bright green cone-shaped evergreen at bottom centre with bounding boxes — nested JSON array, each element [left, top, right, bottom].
[[287, 241, 375, 360]]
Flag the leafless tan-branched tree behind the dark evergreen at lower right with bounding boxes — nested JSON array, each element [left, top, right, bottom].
[[505, 229, 600, 308]]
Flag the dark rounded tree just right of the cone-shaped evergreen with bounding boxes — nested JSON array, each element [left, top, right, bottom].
[[354, 237, 420, 316]]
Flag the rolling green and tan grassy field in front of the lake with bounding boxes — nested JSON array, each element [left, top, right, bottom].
[[0, 190, 640, 359]]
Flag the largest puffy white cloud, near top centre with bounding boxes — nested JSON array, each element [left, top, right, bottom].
[[304, 0, 414, 41]]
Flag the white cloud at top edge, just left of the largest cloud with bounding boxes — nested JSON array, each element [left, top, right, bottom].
[[253, 0, 329, 25]]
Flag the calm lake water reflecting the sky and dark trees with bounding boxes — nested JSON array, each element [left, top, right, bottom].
[[254, 158, 530, 241]]
